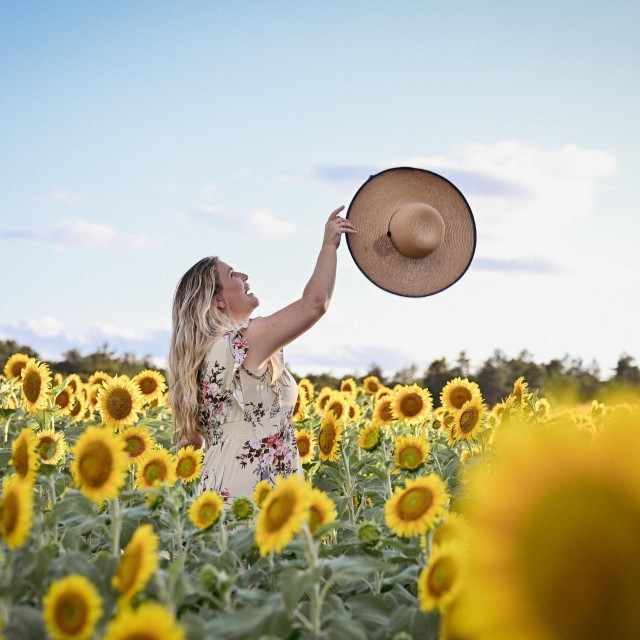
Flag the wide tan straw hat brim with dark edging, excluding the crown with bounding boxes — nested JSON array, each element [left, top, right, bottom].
[[345, 167, 477, 297]]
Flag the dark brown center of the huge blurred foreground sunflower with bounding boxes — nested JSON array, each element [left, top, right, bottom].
[[516, 479, 640, 640]]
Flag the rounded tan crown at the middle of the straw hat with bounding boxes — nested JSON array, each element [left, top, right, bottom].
[[388, 202, 445, 259]]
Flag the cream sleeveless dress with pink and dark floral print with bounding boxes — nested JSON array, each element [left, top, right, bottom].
[[197, 320, 302, 499]]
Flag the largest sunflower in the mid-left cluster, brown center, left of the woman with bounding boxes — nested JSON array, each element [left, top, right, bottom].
[[71, 427, 128, 503]]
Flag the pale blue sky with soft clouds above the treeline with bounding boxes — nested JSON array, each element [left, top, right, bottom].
[[0, 0, 640, 379]]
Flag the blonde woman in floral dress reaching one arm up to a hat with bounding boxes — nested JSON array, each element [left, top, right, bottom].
[[168, 206, 356, 499]]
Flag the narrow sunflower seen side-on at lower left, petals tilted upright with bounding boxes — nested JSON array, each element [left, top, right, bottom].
[[111, 523, 158, 607]]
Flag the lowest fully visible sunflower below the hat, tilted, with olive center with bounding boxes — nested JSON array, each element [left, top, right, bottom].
[[384, 473, 447, 538]]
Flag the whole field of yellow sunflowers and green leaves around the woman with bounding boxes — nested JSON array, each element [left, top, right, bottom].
[[0, 353, 640, 640]]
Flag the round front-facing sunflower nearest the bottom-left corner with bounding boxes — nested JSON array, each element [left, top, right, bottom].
[[42, 573, 102, 640]]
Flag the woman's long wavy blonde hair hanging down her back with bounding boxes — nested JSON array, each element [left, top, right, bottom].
[[167, 256, 233, 443]]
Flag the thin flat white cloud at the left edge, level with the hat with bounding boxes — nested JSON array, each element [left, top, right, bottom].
[[0, 218, 159, 249]]
